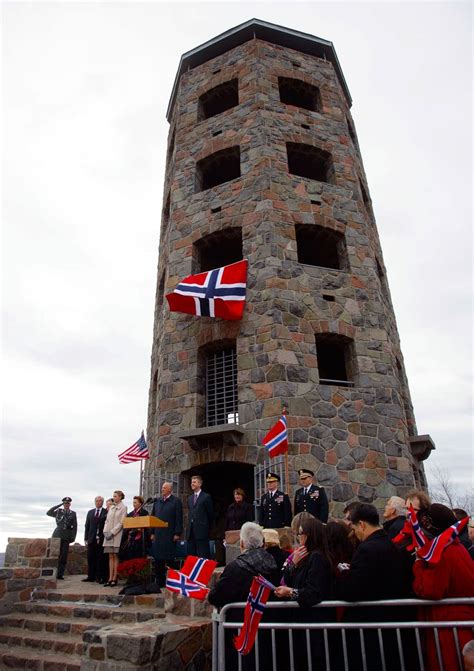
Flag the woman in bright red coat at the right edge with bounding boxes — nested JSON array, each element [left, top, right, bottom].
[[413, 503, 474, 671]]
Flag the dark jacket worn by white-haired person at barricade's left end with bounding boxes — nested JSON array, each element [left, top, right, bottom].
[[207, 548, 278, 608]]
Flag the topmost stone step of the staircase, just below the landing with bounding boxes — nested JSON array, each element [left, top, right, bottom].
[[31, 586, 165, 608]]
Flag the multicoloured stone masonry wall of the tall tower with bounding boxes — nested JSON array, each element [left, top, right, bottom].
[[146, 34, 417, 516]]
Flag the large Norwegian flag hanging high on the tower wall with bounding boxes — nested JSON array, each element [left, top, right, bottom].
[[166, 260, 248, 320]]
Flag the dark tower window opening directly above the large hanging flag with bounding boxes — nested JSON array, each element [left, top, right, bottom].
[[193, 226, 243, 273]]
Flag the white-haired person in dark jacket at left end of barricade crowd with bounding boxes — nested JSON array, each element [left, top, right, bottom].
[[207, 522, 279, 608]]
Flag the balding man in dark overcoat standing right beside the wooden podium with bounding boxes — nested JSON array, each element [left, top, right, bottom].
[[151, 482, 183, 587]]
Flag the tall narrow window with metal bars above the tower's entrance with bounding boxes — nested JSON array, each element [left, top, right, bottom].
[[206, 345, 239, 426]]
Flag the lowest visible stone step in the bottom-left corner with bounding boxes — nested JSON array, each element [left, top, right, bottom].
[[0, 645, 81, 671]]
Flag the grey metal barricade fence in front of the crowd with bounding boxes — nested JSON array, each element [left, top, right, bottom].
[[212, 598, 474, 671]]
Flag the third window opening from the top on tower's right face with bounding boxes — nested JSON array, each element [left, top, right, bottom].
[[295, 224, 347, 270]]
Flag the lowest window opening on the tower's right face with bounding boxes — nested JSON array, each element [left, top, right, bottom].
[[316, 333, 355, 387]]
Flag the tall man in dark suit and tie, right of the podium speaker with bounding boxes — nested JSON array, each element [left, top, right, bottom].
[[187, 475, 214, 559]]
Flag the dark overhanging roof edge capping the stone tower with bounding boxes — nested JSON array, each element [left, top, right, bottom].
[[166, 19, 352, 121]]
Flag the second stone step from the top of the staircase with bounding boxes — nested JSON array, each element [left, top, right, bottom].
[[15, 601, 165, 624]]
